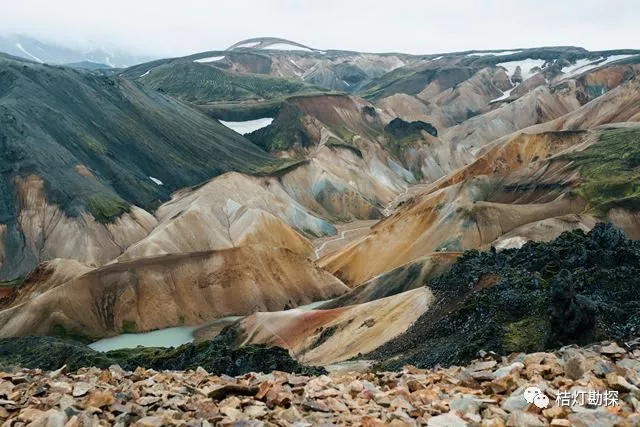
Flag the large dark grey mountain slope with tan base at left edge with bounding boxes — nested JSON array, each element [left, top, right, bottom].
[[0, 56, 280, 277]]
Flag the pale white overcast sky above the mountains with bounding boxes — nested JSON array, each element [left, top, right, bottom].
[[0, 0, 640, 56]]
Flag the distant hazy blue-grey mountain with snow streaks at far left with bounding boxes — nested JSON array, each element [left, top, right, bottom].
[[0, 35, 152, 68]]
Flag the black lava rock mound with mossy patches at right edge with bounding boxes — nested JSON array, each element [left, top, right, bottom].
[[370, 223, 640, 370]]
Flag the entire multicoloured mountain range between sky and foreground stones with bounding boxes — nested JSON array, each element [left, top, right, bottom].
[[0, 38, 640, 384]]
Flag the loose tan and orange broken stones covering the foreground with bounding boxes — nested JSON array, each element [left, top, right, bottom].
[[0, 340, 640, 426]]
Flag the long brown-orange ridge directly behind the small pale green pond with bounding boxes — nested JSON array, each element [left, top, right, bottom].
[[0, 245, 348, 340]]
